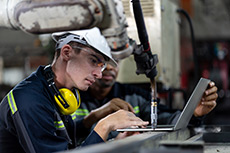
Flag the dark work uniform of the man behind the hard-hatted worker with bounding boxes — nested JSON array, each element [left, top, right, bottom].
[[76, 82, 200, 144]]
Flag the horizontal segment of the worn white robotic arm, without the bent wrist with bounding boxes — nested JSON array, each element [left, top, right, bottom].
[[0, 0, 104, 31]]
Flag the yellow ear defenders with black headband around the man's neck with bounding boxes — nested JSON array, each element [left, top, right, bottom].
[[44, 65, 81, 115]]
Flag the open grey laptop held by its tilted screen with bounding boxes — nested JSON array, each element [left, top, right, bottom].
[[116, 78, 210, 132]]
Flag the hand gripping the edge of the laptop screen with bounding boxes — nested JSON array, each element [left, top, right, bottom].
[[194, 82, 218, 117]]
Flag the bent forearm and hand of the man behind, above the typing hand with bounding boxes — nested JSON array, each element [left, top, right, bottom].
[[83, 98, 134, 128]]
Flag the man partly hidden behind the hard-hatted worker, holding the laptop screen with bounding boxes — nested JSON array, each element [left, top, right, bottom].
[[76, 64, 218, 143]]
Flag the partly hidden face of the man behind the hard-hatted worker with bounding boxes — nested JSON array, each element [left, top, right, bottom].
[[92, 64, 119, 88]]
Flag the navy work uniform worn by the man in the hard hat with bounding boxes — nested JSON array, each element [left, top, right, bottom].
[[0, 66, 103, 153]]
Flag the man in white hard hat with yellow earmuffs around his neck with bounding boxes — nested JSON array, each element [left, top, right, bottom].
[[0, 28, 148, 153]]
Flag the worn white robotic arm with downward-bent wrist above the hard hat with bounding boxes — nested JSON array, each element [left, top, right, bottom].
[[0, 0, 133, 59]]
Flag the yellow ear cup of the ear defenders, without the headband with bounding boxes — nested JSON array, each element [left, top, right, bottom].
[[54, 88, 81, 115]]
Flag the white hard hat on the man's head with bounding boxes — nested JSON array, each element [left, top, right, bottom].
[[52, 27, 117, 67]]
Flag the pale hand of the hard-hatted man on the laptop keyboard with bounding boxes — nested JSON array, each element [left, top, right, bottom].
[[94, 110, 149, 141]]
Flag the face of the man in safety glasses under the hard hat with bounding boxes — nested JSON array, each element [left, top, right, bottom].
[[66, 47, 105, 90]]
